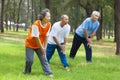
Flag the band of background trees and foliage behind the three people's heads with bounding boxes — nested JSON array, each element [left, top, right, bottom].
[[0, 0, 114, 37]]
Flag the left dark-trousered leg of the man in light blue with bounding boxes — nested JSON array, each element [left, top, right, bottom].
[[70, 34, 82, 58]]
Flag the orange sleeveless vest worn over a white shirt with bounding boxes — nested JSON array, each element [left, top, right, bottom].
[[25, 20, 51, 49]]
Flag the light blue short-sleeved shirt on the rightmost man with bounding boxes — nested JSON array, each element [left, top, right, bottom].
[[76, 17, 99, 38]]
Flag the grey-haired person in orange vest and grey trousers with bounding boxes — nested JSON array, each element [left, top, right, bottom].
[[24, 9, 53, 77]]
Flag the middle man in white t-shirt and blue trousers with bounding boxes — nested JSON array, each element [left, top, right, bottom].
[[46, 14, 70, 71]]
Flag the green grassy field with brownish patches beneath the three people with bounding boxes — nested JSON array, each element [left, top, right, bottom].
[[0, 32, 120, 80]]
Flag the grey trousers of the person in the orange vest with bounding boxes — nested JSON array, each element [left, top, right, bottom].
[[26, 47, 52, 75]]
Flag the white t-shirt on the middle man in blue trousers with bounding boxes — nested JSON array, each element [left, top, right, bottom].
[[48, 21, 70, 44]]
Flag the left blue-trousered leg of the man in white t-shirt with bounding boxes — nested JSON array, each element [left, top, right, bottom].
[[46, 44, 56, 62]]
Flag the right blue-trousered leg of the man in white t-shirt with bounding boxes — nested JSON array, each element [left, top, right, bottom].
[[57, 46, 69, 67]]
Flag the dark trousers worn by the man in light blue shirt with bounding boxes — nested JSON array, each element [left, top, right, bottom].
[[70, 33, 92, 62]]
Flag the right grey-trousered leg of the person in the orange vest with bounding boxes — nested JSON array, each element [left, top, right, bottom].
[[35, 49, 52, 75]]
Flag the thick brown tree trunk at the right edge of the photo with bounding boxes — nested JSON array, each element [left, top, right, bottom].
[[114, 0, 120, 55]]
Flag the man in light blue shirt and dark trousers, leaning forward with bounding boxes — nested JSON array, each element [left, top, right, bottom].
[[70, 11, 100, 62]]
